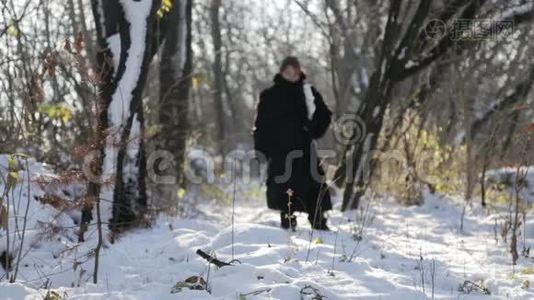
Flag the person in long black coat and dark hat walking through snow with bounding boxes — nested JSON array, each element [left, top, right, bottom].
[[253, 56, 332, 230]]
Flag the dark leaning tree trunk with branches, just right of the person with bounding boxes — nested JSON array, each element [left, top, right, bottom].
[[342, 0, 534, 210]]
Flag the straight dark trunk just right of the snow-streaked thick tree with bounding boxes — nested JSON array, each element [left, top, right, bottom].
[[157, 0, 193, 210]]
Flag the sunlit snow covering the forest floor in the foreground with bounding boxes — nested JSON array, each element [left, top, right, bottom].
[[0, 156, 534, 300]]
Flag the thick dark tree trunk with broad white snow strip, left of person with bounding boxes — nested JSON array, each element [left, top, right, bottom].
[[81, 0, 159, 233]]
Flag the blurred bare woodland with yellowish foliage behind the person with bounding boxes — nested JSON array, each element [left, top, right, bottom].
[[0, 0, 534, 226]]
